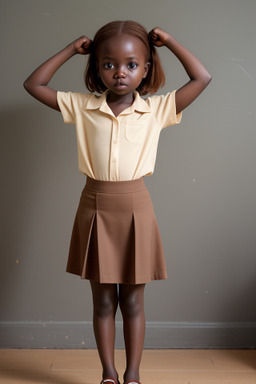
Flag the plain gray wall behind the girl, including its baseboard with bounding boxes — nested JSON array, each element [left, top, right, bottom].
[[0, 0, 256, 348]]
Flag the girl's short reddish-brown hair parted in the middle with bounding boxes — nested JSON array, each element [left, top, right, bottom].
[[84, 20, 165, 95]]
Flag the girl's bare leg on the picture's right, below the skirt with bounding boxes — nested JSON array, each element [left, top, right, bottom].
[[119, 284, 145, 382]]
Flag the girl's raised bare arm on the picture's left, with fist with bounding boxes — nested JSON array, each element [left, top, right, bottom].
[[23, 36, 91, 111]]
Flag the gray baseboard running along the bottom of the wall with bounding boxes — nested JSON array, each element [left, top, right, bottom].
[[0, 322, 256, 349]]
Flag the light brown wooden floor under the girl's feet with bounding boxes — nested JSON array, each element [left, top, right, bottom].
[[0, 349, 256, 384]]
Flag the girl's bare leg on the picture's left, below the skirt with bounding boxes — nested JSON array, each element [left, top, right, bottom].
[[91, 281, 118, 379]]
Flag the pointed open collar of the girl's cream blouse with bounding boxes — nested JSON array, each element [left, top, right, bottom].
[[86, 91, 151, 115]]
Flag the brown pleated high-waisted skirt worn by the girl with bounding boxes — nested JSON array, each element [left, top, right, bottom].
[[67, 177, 167, 284]]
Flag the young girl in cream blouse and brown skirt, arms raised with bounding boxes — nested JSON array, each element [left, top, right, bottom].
[[24, 21, 211, 384]]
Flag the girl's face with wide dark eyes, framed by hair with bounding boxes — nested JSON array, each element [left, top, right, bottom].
[[97, 34, 150, 96]]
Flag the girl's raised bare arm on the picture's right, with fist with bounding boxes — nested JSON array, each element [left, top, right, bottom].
[[149, 27, 212, 114]]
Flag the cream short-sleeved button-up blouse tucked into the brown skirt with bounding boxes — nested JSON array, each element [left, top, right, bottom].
[[57, 91, 182, 181]]
